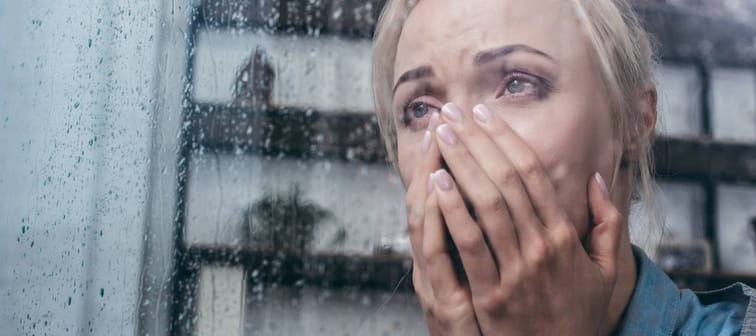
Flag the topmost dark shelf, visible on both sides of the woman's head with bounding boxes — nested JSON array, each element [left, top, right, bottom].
[[194, 0, 756, 66]]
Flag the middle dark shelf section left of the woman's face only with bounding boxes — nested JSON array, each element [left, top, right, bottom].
[[190, 104, 386, 163]]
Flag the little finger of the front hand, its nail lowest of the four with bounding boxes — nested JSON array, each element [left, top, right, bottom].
[[433, 169, 499, 297]]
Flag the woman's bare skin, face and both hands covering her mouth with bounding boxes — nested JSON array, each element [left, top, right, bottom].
[[393, 0, 656, 335]]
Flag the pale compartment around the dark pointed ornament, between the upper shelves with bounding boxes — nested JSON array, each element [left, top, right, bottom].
[[193, 30, 373, 113]]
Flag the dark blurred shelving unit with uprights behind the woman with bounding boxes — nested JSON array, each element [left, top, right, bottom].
[[171, 0, 756, 335]]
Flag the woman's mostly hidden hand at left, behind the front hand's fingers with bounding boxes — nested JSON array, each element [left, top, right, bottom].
[[406, 113, 481, 336]]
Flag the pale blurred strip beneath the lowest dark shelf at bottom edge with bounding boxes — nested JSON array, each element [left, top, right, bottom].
[[244, 287, 428, 336]]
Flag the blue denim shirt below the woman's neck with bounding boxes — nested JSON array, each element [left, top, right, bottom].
[[616, 246, 756, 336]]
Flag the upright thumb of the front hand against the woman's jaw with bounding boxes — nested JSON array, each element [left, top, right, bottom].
[[586, 172, 622, 279]]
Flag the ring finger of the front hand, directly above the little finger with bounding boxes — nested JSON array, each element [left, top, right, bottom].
[[437, 124, 519, 267]]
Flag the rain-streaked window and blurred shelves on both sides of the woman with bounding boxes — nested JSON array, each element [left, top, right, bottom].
[[0, 0, 756, 335]]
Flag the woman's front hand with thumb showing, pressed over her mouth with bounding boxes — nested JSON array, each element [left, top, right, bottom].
[[422, 104, 622, 335]]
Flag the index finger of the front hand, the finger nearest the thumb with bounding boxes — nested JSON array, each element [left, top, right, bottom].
[[473, 104, 568, 227]]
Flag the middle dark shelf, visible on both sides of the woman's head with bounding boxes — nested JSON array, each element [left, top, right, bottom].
[[191, 104, 756, 183]]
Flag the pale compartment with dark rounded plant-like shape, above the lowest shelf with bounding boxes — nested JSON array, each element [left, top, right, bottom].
[[186, 153, 408, 255]]
